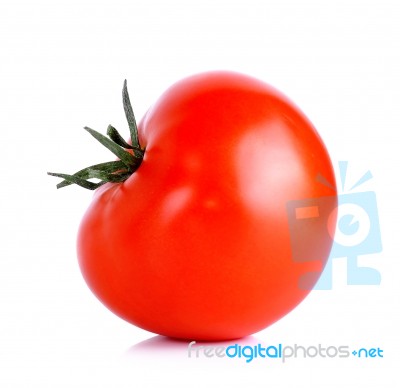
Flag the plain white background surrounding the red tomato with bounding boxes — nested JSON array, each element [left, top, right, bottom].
[[0, 0, 400, 388]]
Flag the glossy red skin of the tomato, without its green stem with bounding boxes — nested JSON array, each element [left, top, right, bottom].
[[78, 72, 336, 340]]
